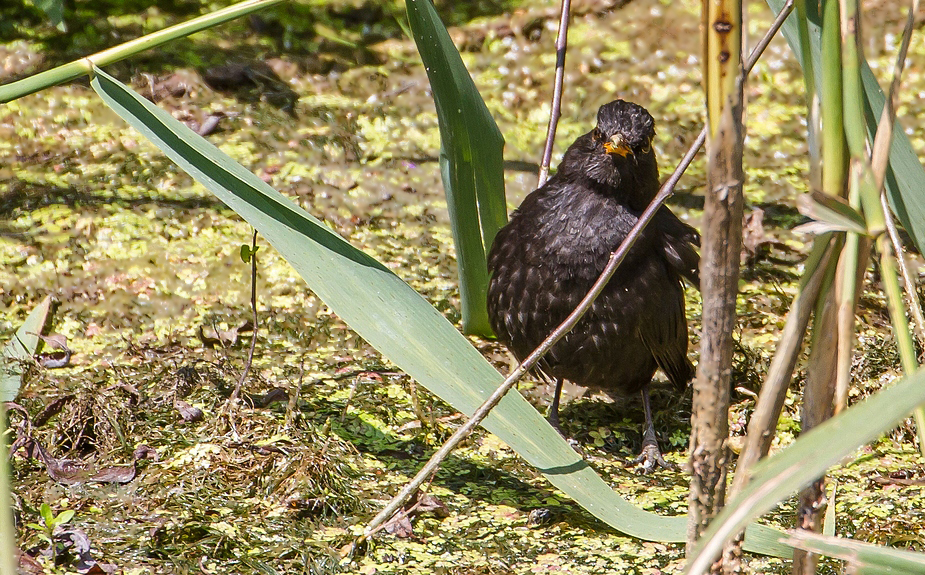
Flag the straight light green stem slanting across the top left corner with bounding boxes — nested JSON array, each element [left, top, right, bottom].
[[0, 0, 283, 104]]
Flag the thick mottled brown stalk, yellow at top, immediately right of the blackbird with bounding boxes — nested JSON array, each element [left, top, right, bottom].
[[688, 0, 744, 570]]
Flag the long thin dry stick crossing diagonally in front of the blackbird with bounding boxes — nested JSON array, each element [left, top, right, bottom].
[[354, 1, 793, 548]]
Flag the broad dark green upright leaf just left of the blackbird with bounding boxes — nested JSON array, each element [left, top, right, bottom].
[[407, 0, 507, 335]]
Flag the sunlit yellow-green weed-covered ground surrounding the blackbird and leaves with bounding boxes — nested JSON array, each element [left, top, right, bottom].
[[0, 0, 925, 574]]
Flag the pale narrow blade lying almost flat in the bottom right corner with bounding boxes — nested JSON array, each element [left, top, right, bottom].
[[787, 531, 925, 575]]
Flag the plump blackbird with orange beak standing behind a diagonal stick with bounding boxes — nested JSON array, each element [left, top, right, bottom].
[[488, 100, 700, 472]]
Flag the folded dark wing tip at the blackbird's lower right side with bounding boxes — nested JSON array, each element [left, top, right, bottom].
[[638, 288, 694, 389]]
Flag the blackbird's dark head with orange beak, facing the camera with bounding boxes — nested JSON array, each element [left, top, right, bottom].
[[559, 100, 658, 197]]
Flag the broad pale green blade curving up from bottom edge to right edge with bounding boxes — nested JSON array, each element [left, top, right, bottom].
[[687, 370, 925, 573]]
